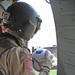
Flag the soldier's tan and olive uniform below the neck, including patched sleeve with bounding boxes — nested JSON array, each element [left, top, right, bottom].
[[0, 37, 35, 75]]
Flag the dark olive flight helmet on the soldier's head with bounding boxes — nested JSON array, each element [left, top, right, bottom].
[[2, 2, 42, 40]]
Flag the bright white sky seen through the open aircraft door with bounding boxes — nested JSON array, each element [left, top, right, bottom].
[[20, 0, 57, 49]]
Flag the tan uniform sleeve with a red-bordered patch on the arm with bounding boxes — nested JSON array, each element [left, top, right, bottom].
[[0, 48, 35, 75]]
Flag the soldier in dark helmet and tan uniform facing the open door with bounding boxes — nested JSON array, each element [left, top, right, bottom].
[[0, 2, 42, 75]]
